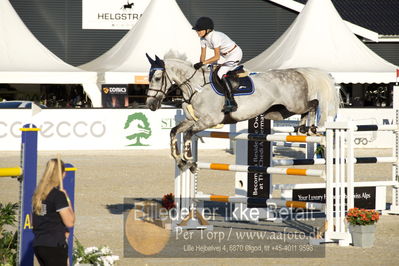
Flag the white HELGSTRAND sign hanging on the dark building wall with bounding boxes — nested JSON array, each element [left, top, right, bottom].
[[82, 0, 151, 30]]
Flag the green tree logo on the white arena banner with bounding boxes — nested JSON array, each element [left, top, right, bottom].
[[124, 113, 152, 146]]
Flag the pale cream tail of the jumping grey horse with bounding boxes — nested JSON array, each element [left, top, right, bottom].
[[296, 68, 340, 127]]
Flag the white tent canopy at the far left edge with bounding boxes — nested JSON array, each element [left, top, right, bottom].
[[0, 0, 101, 107]]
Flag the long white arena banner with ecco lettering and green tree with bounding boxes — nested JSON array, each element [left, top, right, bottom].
[[0, 109, 230, 151]]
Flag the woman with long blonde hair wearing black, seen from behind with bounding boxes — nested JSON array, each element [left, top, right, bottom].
[[32, 159, 75, 266]]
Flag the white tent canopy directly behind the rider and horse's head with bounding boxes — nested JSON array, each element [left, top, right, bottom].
[[80, 0, 200, 83]]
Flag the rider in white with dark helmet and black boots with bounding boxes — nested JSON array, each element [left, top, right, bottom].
[[193, 17, 242, 113]]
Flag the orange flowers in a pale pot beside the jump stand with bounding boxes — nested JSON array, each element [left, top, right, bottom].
[[346, 208, 380, 248]]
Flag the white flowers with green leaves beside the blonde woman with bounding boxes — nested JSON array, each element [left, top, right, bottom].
[[73, 239, 119, 266]]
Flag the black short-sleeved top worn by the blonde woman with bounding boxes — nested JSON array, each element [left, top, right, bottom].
[[32, 188, 69, 247]]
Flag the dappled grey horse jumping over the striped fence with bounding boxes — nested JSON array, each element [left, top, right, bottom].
[[146, 53, 340, 169]]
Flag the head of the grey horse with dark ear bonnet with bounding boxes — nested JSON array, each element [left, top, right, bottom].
[[146, 54, 172, 111]]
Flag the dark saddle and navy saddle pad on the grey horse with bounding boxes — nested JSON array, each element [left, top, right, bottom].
[[209, 65, 255, 96]]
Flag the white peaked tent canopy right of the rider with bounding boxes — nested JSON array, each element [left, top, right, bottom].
[[245, 0, 397, 83]]
